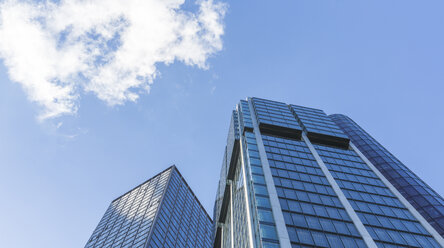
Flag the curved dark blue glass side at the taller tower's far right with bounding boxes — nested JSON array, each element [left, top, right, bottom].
[[331, 114, 444, 237]]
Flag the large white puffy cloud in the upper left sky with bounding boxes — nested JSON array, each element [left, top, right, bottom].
[[0, 0, 226, 119]]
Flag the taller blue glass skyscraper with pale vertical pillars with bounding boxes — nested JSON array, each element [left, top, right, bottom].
[[213, 98, 444, 248]]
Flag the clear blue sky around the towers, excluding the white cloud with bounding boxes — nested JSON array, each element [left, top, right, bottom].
[[0, 0, 444, 248]]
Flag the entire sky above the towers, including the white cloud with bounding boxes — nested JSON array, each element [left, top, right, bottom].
[[0, 0, 444, 248]]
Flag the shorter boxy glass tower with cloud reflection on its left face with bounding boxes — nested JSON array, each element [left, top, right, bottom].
[[85, 166, 212, 248]]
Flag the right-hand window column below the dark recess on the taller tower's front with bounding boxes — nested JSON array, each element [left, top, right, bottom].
[[314, 145, 439, 247]]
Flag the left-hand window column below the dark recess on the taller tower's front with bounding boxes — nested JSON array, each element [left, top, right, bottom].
[[262, 135, 366, 247]]
